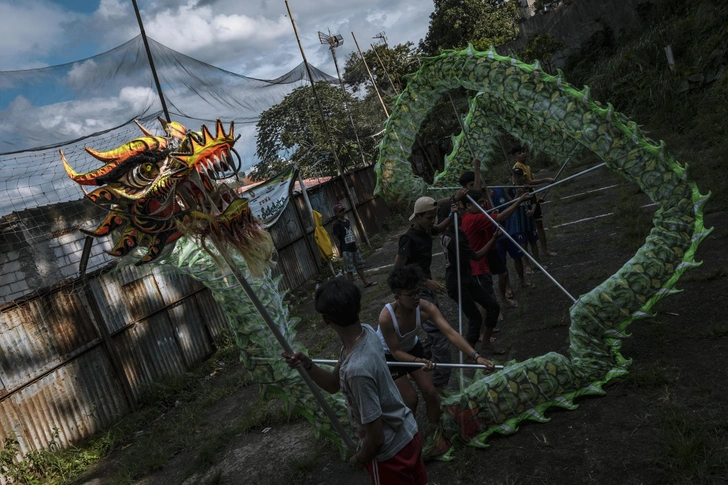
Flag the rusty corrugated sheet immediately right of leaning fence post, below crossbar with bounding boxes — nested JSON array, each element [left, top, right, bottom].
[[112, 312, 186, 399]]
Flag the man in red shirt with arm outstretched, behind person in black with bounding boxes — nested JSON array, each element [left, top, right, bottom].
[[460, 190, 528, 349]]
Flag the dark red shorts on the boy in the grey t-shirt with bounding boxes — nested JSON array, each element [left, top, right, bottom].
[[367, 431, 428, 485]]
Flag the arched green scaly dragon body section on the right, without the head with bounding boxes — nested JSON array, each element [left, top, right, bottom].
[[375, 46, 710, 454]]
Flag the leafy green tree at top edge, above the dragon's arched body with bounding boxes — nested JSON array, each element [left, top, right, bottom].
[[420, 0, 520, 55]]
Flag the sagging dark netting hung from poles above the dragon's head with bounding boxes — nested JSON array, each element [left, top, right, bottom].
[[0, 36, 335, 216]]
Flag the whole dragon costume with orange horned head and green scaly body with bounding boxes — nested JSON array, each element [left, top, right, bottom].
[[62, 46, 710, 459]]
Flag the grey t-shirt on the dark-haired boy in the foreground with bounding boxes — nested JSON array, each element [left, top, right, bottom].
[[339, 325, 417, 461]]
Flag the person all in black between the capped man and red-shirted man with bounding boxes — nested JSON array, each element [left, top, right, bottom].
[[439, 202, 505, 354]]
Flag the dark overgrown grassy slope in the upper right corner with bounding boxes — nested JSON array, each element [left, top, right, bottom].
[[564, 0, 728, 212]]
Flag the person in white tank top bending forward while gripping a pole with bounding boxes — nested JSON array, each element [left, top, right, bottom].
[[377, 264, 494, 457]]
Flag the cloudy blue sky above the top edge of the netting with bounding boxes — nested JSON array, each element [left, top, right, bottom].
[[0, 0, 433, 79]]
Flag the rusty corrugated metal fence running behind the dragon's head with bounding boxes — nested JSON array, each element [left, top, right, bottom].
[[0, 167, 390, 452]]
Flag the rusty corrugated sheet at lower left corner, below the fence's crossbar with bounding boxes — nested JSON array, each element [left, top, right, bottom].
[[4, 347, 129, 452]]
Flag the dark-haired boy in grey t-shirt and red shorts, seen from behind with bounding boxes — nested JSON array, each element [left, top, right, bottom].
[[283, 278, 427, 485]]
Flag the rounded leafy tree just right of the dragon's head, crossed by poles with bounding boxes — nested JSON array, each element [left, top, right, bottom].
[[249, 82, 378, 180]]
